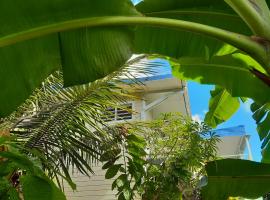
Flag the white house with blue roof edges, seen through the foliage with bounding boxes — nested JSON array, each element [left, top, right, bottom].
[[65, 73, 251, 200]]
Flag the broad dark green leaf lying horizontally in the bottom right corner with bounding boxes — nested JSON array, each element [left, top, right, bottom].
[[202, 159, 270, 200]]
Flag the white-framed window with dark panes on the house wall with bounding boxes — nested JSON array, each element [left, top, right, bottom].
[[104, 103, 132, 122]]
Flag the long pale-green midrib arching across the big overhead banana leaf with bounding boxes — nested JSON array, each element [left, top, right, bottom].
[[0, 16, 270, 68]]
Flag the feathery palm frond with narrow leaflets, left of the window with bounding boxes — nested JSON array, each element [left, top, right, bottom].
[[0, 57, 154, 199]]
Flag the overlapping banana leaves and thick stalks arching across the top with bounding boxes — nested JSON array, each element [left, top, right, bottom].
[[0, 0, 270, 161]]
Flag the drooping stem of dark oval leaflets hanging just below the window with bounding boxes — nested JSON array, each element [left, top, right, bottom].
[[101, 129, 146, 200]]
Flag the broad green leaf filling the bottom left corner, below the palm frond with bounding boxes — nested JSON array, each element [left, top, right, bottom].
[[0, 136, 66, 200]]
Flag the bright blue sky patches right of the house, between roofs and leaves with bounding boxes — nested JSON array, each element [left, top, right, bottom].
[[188, 82, 261, 161]]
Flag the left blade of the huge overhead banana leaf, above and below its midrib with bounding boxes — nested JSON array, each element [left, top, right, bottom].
[[0, 0, 138, 117]]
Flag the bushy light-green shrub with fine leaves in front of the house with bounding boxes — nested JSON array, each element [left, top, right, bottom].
[[134, 113, 218, 200]]
